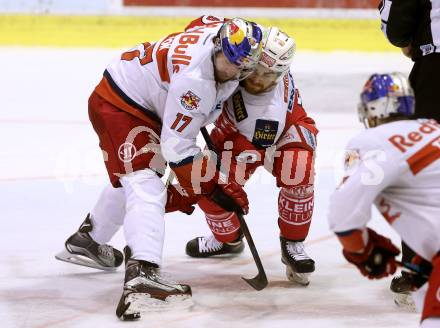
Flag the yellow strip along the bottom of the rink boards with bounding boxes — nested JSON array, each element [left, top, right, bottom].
[[0, 13, 397, 52]]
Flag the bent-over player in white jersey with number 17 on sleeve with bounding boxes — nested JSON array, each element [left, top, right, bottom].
[[54, 17, 262, 320]]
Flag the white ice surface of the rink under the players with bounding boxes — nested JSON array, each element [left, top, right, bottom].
[[0, 48, 419, 328]]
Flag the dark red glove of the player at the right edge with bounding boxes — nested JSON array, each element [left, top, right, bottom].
[[342, 229, 400, 279]]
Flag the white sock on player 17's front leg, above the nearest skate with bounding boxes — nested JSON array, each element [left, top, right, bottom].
[[120, 169, 166, 265]]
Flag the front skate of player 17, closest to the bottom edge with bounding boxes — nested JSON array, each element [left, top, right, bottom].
[[116, 246, 192, 321]]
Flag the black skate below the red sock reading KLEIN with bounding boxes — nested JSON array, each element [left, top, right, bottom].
[[280, 237, 315, 286]]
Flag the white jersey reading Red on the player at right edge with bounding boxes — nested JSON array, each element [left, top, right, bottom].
[[328, 120, 440, 261]]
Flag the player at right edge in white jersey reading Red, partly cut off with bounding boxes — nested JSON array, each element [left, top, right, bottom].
[[328, 73, 440, 328]]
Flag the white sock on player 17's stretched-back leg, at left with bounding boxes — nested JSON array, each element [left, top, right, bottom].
[[90, 184, 125, 244]]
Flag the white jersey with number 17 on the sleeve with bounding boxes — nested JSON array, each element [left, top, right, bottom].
[[95, 22, 238, 163]]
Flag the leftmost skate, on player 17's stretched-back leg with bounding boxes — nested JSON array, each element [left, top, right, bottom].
[[55, 214, 124, 271]]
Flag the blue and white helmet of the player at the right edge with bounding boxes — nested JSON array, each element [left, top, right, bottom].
[[358, 72, 414, 127]]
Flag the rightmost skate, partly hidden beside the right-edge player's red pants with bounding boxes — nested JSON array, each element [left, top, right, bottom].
[[390, 271, 416, 312]]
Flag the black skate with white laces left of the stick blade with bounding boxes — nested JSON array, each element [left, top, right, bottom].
[[186, 235, 244, 257]]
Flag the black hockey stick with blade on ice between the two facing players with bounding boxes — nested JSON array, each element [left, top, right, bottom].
[[201, 127, 268, 290]]
